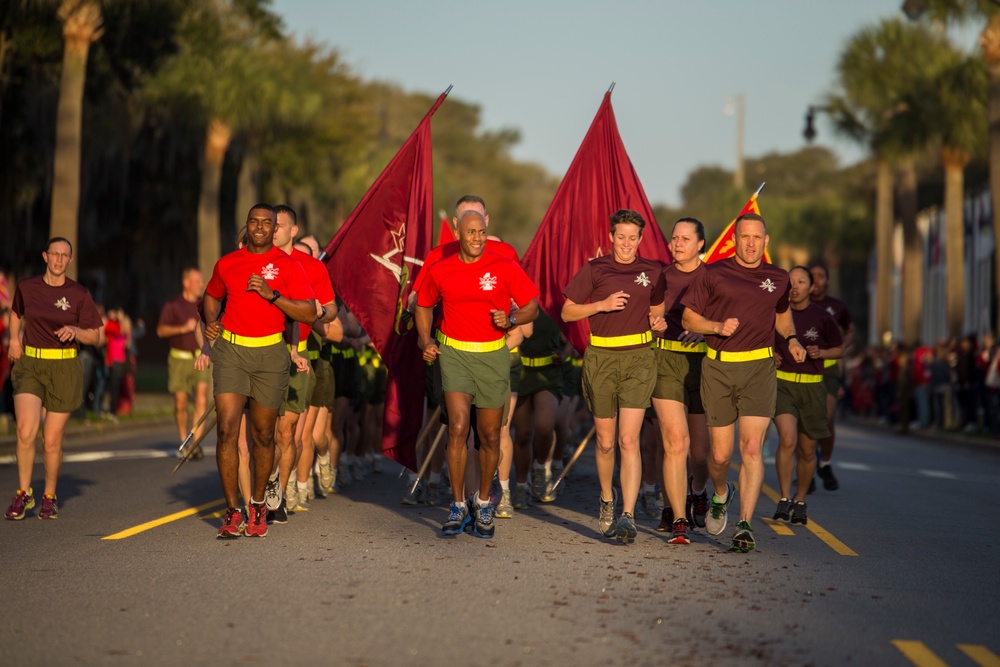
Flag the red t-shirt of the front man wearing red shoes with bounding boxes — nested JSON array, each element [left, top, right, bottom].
[[205, 247, 313, 338]]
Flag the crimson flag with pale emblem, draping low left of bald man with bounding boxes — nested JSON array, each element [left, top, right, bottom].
[[324, 91, 451, 470]]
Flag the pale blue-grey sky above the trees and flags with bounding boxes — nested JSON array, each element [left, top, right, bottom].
[[272, 0, 976, 207]]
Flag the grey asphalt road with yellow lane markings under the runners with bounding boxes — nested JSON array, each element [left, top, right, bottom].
[[0, 426, 1000, 667]]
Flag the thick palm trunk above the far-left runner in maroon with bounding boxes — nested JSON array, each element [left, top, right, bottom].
[[49, 0, 103, 280]]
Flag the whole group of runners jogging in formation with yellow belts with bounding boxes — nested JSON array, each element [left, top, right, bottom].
[[6, 195, 851, 552]]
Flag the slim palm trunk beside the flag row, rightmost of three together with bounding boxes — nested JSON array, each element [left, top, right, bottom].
[[941, 148, 969, 340]]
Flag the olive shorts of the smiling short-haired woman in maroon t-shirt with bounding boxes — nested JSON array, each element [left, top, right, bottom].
[[582, 345, 656, 419]]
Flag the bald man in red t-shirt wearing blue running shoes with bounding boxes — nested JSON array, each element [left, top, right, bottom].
[[415, 209, 538, 538]]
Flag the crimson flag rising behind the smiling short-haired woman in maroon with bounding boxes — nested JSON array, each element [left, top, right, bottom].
[[521, 91, 673, 352]]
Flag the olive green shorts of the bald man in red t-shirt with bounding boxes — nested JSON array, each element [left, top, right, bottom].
[[438, 344, 510, 410]]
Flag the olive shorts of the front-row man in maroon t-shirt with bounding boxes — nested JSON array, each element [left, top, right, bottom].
[[701, 356, 778, 426]]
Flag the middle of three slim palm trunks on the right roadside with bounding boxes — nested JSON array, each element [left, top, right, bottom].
[[896, 157, 924, 345]]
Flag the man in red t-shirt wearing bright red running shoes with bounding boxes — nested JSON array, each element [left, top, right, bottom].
[[204, 204, 316, 538]]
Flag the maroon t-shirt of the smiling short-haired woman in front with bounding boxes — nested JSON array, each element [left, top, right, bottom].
[[563, 254, 664, 350]]
